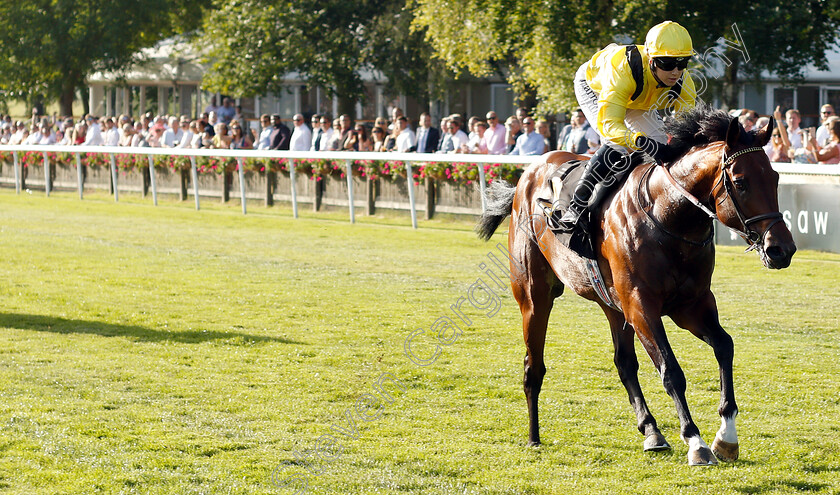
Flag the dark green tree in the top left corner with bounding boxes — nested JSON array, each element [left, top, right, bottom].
[[0, 0, 202, 115]]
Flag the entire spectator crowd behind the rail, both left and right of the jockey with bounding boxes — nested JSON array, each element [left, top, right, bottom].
[[0, 102, 840, 164]]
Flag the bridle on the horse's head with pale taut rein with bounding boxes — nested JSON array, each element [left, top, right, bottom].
[[646, 143, 782, 255]]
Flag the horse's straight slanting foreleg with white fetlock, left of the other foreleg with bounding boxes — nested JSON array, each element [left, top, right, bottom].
[[622, 300, 717, 466]]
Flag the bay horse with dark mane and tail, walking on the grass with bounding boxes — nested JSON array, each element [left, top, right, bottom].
[[476, 106, 796, 465]]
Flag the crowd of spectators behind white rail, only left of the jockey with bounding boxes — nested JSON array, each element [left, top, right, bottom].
[[0, 105, 597, 155]]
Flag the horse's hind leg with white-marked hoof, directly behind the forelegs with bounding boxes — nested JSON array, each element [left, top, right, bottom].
[[604, 308, 671, 452]]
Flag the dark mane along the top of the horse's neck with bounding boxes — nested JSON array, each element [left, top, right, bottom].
[[665, 104, 755, 161]]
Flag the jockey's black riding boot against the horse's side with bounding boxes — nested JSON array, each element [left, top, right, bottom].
[[558, 145, 629, 232]]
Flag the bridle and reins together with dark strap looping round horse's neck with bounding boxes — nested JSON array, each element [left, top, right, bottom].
[[639, 147, 782, 252]]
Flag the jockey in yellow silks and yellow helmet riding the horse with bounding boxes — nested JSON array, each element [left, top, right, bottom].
[[559, 21, 696, 231]]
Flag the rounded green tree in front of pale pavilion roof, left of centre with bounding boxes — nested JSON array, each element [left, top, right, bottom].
[[197, 0, 452, 113]]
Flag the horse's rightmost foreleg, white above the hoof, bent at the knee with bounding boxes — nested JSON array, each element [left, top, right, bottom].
[[671, 292, 739, 461]]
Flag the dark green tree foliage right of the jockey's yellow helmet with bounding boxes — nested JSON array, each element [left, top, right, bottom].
[[619, 0, 840, 108]]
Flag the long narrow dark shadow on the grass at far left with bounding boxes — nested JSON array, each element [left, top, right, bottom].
[[0, 313, 303, 345]]
